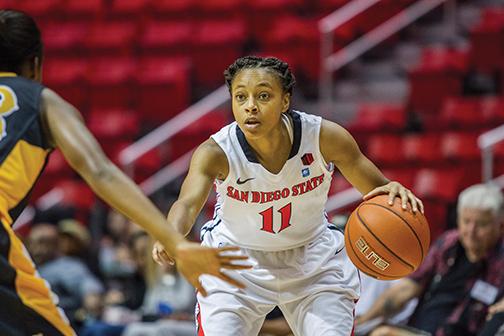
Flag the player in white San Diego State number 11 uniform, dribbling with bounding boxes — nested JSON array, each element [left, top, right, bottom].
[[153, 56, 423, 336]]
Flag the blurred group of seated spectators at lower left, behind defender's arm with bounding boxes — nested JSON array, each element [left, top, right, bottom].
[[25, 207, 196, 336]]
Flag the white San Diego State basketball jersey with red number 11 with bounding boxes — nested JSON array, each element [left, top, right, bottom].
[[202, 111, 332, 251]]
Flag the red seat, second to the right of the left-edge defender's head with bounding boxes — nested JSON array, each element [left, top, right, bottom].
[[84, 21, 137, 56]]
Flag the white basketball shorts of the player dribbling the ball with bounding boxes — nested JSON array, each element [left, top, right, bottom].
[[196, 228, 360, 336]]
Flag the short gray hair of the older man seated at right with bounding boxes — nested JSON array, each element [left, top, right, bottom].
[[457, 183, 504, 217]]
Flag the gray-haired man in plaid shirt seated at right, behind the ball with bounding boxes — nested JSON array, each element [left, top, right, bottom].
[[357, 184, 504, 336]]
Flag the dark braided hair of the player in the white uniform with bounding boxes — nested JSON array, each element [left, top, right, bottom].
[[224, 56, 296, 94]]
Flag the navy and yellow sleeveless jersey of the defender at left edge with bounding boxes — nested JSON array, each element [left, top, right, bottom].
[[0, 72, 51, 225]]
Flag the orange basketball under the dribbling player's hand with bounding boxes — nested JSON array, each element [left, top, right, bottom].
[[345, 195, 430, 280]]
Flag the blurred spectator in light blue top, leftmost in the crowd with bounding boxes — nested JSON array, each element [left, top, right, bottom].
[[27, 223, 104, 324]]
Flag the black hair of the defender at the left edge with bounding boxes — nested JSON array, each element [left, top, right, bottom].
[[0, 9, 43, 73]]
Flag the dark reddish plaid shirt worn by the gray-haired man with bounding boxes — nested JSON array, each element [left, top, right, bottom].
[[409, 230, 504, 336]]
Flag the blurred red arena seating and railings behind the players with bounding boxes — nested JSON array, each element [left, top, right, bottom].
[[0, 0, 504, 334]]
